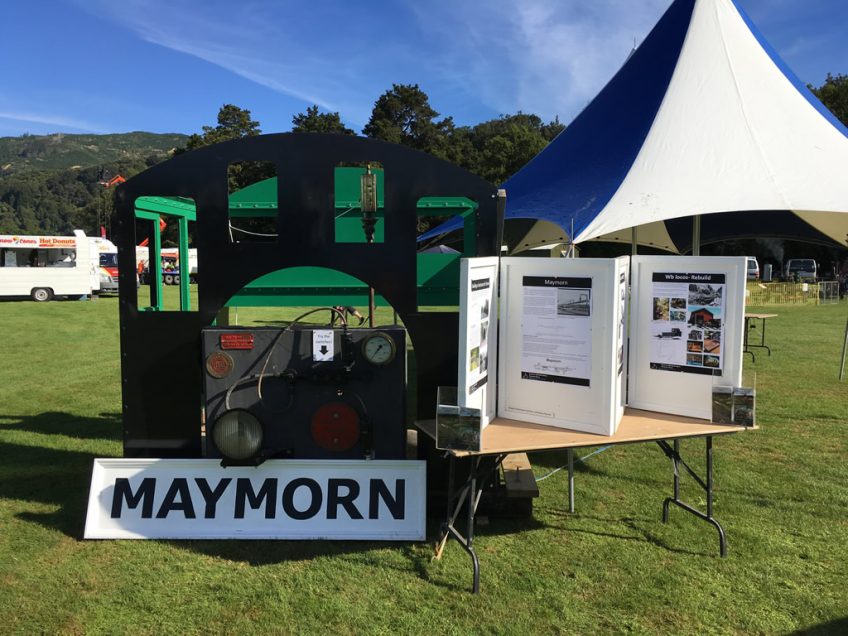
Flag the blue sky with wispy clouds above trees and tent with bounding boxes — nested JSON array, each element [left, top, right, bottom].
[[0, 0, 848, 136]]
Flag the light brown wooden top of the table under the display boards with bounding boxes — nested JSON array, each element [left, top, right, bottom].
[[415, 408, 756, 457]]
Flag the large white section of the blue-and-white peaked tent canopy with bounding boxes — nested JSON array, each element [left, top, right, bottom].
[[575, 0, 848, 245]]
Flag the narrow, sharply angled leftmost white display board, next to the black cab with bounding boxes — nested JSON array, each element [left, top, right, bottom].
[[457, 256, 499, 427]]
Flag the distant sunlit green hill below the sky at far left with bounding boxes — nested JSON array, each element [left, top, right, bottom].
[[0, 132, 188, 176]]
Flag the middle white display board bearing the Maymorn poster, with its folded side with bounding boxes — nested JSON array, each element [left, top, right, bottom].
[[498, 256, 629, 435]]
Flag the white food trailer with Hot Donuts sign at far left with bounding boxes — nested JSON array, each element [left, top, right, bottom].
[[0, 230, 99, 302]]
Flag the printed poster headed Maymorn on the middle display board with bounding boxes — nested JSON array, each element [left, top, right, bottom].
[[521, 276, 592, 387]]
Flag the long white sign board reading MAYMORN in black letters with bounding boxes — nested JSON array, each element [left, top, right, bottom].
[[85, 459, 426, 541]]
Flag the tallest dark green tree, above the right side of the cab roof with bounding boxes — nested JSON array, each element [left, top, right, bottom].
[[362, 84, 454, 158]]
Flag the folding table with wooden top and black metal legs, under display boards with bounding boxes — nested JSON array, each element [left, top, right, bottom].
[[417, 409, 747, 593]]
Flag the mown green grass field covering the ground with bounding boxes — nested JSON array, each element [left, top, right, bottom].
[[0, 298, 848, 634]]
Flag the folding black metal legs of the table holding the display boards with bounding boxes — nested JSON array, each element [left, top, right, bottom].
[[436, 435, 727, 594]]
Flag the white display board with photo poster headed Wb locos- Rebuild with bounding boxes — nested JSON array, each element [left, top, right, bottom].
[[628, 256, 746, 419]]
